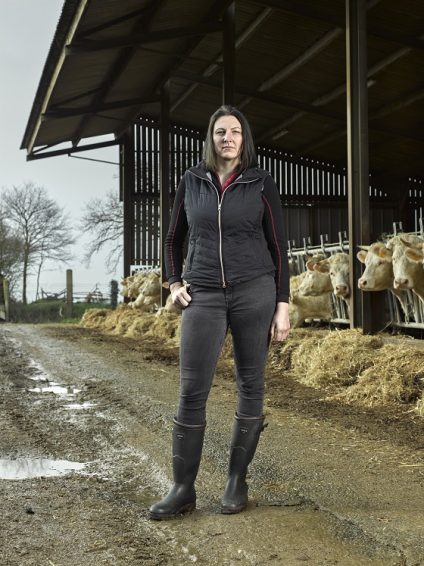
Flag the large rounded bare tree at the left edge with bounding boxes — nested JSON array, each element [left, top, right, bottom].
[[2, 183, 75, 304]]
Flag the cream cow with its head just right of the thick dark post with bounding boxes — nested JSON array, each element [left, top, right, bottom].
[[356, 242, 409, 322]]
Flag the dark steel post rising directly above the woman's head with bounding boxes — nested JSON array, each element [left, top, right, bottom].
[[222, 2, 236, 106]]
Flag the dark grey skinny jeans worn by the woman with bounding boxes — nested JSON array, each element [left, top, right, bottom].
[[177, 274, 276, 424]]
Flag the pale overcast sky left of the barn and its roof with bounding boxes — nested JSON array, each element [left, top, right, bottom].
[[0, 0, 121, 301]]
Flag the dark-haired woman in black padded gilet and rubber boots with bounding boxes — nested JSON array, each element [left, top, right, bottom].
[[150, 106, 290, 520]]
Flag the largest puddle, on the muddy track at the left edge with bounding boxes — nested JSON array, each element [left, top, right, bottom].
[[0, 458, 85, 480]]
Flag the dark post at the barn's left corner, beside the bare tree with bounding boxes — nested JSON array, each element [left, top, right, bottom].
[[120, 126, 135, 277]]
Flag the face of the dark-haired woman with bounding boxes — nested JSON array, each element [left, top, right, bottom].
[[213, 116, 243, 167]]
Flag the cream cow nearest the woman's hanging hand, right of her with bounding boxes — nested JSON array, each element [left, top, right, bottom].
[[289, 272, 332, 328]]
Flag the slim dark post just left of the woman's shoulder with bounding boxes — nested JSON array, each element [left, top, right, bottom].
[[160, 81, 171, 306]]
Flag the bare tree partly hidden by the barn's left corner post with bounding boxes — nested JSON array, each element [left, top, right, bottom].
[[80, 191, 124, 273]]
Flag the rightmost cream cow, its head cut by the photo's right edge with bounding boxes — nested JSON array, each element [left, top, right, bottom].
[[380, 234, 424, 302]]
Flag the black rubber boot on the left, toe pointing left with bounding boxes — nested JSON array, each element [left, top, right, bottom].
[[150, 419, 206, 521]]
